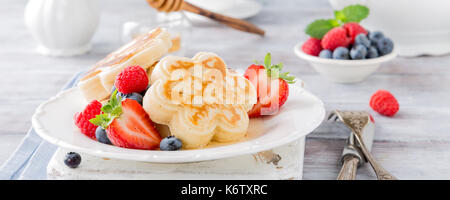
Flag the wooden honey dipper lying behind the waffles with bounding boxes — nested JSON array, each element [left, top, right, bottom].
[[147, 0, 264, 36]]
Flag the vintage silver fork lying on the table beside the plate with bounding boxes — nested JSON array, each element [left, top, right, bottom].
[[328, 110, 397, 180]]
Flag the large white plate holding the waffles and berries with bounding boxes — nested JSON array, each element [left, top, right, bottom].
[[32, 85, 325, 163]]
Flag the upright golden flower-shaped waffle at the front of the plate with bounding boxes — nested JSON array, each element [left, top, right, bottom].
[[143, 52, 256, 149]]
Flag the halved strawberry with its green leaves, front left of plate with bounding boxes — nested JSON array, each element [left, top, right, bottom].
[[91, 91, 162, 150]]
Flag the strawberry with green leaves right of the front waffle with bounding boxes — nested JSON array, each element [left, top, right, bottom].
[[244, 53, 295, 117]]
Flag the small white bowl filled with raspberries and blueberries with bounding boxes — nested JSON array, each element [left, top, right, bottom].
[[294, 43, 397, 83]]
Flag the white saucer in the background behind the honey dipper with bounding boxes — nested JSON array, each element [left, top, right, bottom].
[[186, 0, 262, 22]]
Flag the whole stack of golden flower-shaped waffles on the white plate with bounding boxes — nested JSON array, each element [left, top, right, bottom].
[[78, 28, 257, 149]]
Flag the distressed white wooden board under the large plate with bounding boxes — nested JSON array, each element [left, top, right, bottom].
[[47, 137, 305, 180]]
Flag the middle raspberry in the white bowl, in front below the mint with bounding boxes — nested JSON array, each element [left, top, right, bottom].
[[322, 27, 351, 51]]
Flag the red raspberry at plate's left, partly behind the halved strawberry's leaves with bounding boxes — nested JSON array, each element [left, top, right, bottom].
[[74, 100, 102, 139]]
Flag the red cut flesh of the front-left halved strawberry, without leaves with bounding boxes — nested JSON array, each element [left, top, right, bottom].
[[107, 99, 162, 150]]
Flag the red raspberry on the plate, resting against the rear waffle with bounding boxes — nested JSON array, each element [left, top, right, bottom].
[[114, 66, 148, 94]]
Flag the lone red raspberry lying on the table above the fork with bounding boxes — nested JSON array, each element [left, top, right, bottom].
[[370, 90, 399, 117]]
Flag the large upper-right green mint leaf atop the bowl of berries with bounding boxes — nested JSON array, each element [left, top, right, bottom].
[[342, 4, 369, 23]]
